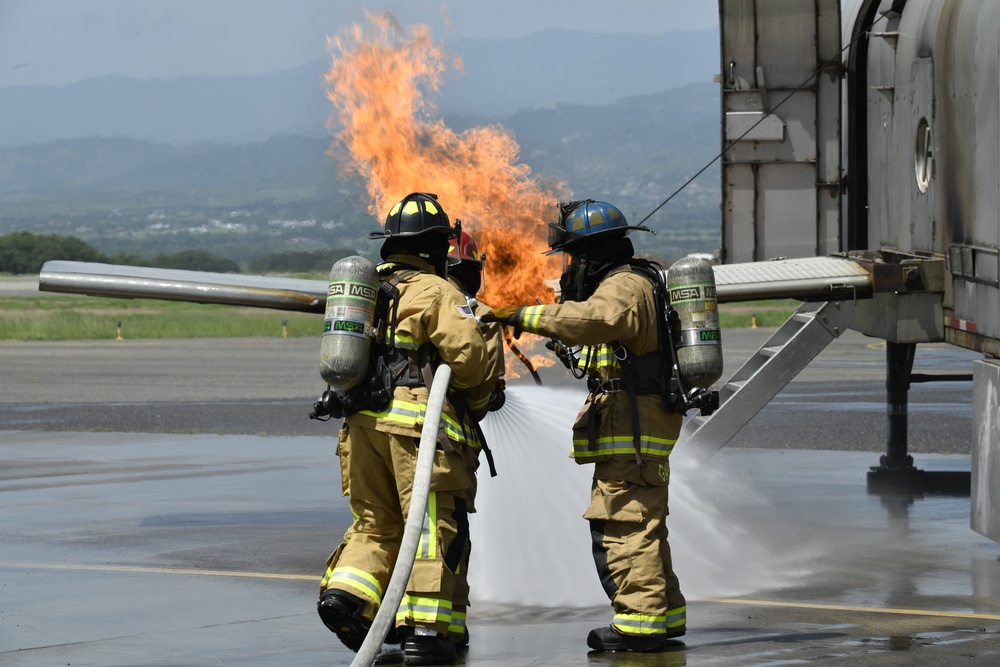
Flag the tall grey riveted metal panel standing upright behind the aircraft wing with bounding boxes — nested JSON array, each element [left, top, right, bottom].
[[720, 0, 843, 264]]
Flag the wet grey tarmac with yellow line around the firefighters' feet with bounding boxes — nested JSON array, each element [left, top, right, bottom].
[[0, 330, 1000, 667]]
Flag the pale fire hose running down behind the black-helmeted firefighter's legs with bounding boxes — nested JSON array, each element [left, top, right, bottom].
[[351, 364, 451, 667]]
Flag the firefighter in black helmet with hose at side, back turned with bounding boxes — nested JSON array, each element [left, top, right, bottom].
[[318, 193, 490, 665]]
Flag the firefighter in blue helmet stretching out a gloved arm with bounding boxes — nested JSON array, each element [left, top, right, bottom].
[[481, 200, 687, 652]]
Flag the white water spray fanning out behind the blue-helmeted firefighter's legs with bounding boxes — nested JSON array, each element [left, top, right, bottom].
[[470, 385, 793, 607]]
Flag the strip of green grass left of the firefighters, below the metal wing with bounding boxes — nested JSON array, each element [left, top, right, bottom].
[[0, 295, 323, 340]]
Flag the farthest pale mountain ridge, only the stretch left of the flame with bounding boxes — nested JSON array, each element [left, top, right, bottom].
[[0, 62, 330, 146]]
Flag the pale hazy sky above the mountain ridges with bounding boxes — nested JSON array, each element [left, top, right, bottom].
[[0, 0, 719, 87]]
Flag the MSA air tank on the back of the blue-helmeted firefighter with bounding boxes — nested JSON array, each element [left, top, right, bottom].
[[667, 257, 722, 389]]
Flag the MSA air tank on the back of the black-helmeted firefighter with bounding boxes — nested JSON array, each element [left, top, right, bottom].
[[319, 256, 378, 393]]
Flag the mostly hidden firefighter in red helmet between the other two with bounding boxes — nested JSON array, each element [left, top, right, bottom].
[[448, 231, 505, 647]]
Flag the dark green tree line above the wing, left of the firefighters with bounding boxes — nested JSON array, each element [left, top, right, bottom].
[[0, 231, 357, 275]]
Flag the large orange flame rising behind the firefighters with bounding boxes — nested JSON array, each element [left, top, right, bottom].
[[325, 12, 569, 375]]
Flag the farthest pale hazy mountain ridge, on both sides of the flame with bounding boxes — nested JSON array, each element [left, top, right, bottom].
[[0, 29, 719, 147]]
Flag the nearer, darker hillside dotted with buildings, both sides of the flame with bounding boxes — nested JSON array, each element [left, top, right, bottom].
[[0, 83, 720, 265]]
